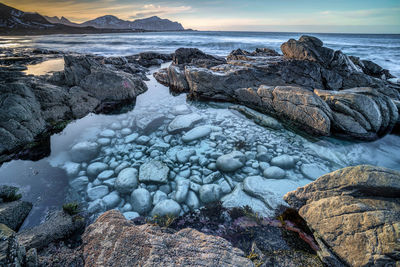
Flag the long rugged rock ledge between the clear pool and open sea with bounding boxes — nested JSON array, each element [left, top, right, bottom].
[[154, 36, 400, 141]]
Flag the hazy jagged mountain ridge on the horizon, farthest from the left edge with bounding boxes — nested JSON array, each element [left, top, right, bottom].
[[73, 15, 185, 31]]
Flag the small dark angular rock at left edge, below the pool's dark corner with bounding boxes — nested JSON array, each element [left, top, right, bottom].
[[0, 200, 32, 231]]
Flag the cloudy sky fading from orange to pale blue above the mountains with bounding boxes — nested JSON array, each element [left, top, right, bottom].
[[0, 0, 400, 33]]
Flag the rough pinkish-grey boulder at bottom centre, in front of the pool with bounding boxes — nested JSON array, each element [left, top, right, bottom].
[[83, 210, 254, 266]]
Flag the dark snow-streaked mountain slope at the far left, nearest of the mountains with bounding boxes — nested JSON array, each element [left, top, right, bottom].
[[0, 3, 54, 29]]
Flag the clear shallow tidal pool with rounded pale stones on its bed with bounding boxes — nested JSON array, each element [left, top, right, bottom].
[[0, 65, 400, 227]]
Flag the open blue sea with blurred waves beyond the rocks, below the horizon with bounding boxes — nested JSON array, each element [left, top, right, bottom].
[[0, 31, 400, 77]]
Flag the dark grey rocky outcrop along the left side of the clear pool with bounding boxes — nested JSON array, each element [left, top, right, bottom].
[[0, 52, 149, 161]]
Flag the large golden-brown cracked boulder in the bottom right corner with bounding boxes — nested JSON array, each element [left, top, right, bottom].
[[285, 165, 400, 266]]
